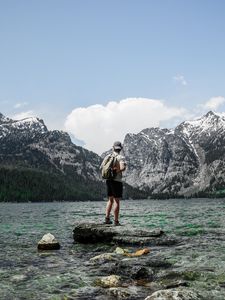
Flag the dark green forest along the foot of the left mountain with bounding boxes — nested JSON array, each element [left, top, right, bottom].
[[0, 167, 104, 202]]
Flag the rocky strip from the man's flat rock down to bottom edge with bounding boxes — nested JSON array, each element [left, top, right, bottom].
[[73, 223, 206, 300]]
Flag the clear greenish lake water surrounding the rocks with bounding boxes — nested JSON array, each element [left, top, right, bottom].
[[0, 199, 225, 300]]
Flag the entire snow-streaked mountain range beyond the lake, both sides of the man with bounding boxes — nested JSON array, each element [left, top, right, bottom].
[[0, 111, 225, 201]]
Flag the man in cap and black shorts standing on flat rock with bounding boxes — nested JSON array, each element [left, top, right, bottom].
[[101, 142, 126, 226]]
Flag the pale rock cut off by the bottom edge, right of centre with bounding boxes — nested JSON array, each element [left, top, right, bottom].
[[145, 288, 202, 300]]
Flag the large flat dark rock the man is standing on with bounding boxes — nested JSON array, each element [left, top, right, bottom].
[[73, 223, 177, 246]]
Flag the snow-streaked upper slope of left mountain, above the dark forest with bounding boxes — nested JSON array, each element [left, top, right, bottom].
[[0, 114, 100, 180]]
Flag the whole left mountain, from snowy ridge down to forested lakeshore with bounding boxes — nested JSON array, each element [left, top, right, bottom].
[[0, 114, 104, 201]]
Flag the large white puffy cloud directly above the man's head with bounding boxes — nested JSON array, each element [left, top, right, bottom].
[[65, 98, 186, 154]]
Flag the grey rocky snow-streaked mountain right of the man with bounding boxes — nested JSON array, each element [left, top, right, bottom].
[[124, 111, 225, 197]]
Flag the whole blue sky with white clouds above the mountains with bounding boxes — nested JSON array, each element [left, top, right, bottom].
[[0, 0, 225, 154]]
